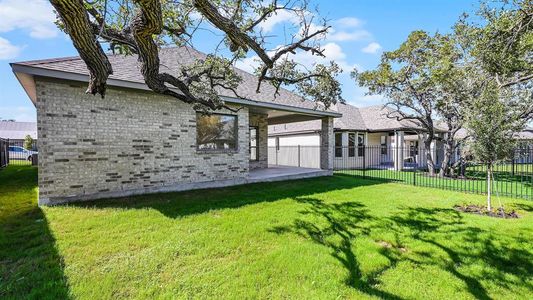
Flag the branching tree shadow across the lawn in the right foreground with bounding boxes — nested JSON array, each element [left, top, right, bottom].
[[270, 197, 533, 299]]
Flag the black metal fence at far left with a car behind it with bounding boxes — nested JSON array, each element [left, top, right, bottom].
[[0, 139, 38, 166]]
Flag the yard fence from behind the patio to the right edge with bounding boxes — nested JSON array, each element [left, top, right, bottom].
[[268, 145, 533, 199]]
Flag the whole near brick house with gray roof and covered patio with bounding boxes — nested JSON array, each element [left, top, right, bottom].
[[11, 47, 340, 204]]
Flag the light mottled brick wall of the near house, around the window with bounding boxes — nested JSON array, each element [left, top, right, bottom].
[[36, 78, 249, 204]]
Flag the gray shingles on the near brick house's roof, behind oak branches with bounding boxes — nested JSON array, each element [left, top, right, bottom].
[[14, 47, 328, 109]]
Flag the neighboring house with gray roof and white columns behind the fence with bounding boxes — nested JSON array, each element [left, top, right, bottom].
[[268, 104, 445, 169]]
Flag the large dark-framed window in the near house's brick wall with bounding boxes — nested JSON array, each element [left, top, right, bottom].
[[196, 113, 237, 150]]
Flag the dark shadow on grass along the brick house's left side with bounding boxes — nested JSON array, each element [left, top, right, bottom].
[[0, 167, 70, 299]]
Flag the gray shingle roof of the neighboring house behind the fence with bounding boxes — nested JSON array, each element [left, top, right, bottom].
[[269, 104, 423, 135]]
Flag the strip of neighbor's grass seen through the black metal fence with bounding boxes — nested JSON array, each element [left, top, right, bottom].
[[336, 164, 533, 199]]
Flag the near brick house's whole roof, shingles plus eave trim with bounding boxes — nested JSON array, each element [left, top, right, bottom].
[[11, 47, 338, 117]]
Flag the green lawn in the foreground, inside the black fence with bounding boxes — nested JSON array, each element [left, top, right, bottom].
[[0, 167, 533, 299]]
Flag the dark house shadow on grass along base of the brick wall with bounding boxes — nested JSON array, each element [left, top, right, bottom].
[[68, 176, 389, 218]]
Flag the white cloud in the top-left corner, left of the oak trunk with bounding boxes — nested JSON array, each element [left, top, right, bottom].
[[0, 0, 58, 39]]
